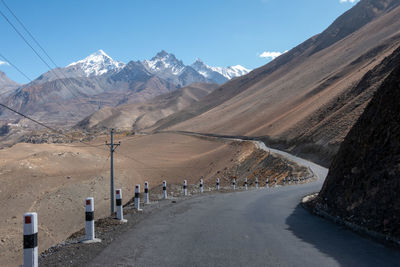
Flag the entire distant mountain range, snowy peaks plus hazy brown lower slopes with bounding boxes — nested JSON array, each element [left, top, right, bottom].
[[0, 50, 250, 125]]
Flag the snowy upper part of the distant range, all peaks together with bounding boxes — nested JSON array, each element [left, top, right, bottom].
[[31, 50, 250, 86]]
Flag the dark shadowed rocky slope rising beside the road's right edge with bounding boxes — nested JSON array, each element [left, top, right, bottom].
[[316, 54, 400, 238]]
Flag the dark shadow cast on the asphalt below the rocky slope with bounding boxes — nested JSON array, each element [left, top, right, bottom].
[[286, 204, 400, 266]]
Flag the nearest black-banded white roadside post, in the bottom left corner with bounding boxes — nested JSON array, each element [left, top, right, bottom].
[[23, 215, 38, 267]]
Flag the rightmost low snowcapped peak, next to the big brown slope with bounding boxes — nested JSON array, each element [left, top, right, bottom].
[[191, 59, 251, 81]]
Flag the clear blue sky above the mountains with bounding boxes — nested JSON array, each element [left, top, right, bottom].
[[0, 0, 357, 83]]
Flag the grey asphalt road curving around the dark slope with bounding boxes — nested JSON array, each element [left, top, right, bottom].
[[91, 141, 400, 266]]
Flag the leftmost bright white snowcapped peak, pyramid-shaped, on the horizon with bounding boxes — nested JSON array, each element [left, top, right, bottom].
[[66, 49, 125, 77]]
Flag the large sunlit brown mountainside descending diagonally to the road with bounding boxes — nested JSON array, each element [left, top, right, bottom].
[[155, 0, 400, 166]]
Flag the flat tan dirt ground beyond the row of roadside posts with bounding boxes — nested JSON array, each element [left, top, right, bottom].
[[0, 134, 262, 266]]
